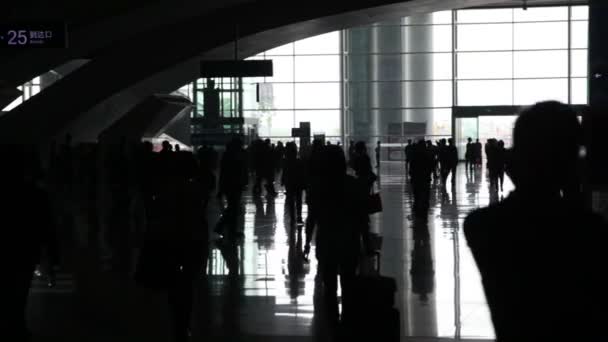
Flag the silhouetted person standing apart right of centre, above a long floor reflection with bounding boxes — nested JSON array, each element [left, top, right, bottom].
[[410, 140, 434, 219]]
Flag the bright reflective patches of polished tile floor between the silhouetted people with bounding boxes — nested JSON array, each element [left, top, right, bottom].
[[201, 162, 512, 340]]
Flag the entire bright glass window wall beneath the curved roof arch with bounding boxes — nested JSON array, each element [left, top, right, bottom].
[[181, 6, 588, 140]]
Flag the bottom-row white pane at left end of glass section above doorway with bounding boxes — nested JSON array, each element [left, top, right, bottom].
[[458, 80, 513, 106]]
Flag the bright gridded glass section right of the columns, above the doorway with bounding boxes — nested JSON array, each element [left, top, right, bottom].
[[455, 6, 588, 106]]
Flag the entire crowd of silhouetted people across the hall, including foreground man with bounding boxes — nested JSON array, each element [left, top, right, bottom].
[[0, 102, 607, 341]]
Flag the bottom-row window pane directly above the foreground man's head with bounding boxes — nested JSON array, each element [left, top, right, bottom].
[[514, 79, 568, 105]]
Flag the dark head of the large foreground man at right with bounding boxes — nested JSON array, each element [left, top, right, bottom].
[[509, 101, 582, 194]]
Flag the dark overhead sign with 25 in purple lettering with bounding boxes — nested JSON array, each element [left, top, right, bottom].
[[0, 23, 68, 49]]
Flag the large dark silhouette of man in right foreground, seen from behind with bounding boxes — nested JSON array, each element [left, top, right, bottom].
[[464, 102, 608, 341]]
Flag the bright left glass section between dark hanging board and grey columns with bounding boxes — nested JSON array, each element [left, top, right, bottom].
[[243, 31, 342, 137]]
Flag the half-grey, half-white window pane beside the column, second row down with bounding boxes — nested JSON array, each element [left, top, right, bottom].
[[403, 25, 452, 52]]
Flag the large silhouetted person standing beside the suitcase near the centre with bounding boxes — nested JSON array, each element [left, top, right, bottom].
[[316, 146, 369, 326]]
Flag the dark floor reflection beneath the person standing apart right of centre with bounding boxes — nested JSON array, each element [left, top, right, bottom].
[[410, 220, 435, 303]]
